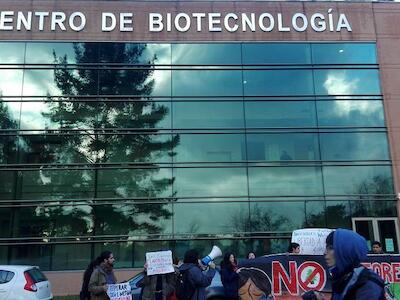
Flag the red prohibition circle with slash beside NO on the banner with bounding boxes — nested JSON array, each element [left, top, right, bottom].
[[298, 261, 326, 291]]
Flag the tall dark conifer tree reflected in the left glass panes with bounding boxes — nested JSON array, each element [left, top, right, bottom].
[[17, 43, 178, 239]]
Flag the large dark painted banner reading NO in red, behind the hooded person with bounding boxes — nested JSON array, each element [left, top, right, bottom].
[[239, 254, 400, 300]]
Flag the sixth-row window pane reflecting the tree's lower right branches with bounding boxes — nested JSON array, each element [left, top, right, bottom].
[[93, 203, 172, 236]]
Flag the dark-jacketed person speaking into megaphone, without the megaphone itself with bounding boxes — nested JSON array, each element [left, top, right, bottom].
[[177, 250, 215, 300]]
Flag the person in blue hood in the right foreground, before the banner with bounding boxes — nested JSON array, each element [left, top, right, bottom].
[[325, 229, 385, 300]]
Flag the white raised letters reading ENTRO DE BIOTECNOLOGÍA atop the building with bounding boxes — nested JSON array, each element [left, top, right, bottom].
[[0, 8, 352, 33]]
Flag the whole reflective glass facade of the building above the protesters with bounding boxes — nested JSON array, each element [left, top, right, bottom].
[[0, 42, 396, 270]]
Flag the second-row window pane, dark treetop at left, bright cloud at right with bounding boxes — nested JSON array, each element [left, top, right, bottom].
[[99, 69, 171, 96]]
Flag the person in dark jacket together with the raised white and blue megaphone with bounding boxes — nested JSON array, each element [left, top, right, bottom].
[[176, 246, 222, 300]]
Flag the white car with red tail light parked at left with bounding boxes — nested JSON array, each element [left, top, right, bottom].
[[0, 265, 53, 300]]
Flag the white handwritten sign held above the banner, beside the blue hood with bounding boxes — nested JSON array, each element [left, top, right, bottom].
[[292, 228, 332, 255]]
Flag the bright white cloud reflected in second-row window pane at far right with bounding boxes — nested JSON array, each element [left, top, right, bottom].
[[324, 70, 360, 95]]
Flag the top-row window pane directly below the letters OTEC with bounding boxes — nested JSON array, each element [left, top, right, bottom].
[[172, 43, 242, 65]]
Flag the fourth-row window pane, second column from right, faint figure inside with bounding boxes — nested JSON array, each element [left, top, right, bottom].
[[247, 133, 319, 161]]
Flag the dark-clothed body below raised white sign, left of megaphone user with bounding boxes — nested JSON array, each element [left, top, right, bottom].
[[138, 264, 177, 300]]
